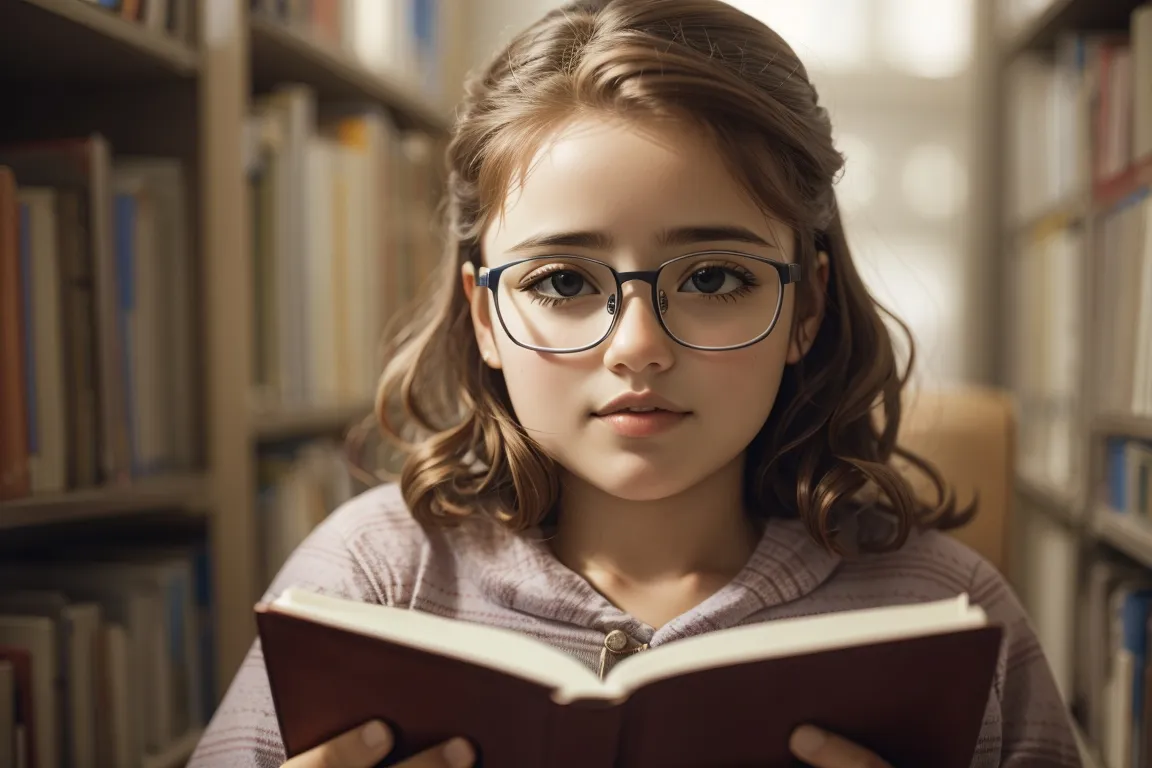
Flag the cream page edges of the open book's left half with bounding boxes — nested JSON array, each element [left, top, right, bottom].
[[264, 588, 602, 692]]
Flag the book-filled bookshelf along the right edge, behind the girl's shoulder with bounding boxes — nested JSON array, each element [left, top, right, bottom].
[[988, 0, 1152, 766]]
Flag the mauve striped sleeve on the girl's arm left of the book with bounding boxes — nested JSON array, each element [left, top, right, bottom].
[[188, 510, 384, 768]]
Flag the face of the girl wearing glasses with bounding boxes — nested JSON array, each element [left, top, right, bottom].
[[463, 119, 813, 501]]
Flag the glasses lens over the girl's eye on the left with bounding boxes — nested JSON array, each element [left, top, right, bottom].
[[497, 256, 619, 350]]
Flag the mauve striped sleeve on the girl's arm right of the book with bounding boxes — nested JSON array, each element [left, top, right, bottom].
[[969, 561, 1082, 768]]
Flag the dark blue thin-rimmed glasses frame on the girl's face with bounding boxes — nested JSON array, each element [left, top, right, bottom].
[[476, 250, 801, 355]]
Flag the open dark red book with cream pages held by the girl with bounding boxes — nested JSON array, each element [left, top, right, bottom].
[[256, 590, 1001, 768]]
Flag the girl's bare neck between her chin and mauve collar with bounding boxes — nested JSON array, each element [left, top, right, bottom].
[[552, 456, 759, 596]]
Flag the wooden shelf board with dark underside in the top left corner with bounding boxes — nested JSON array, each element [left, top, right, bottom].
[[0, 0, 199, 85]]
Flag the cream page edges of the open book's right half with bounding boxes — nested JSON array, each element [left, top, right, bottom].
[[599, 594, 987, 698]]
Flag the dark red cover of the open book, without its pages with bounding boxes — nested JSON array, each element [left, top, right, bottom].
[[257, 606, 1001, 768]]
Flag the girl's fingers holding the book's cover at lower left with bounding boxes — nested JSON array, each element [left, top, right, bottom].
[[281, 721, 476, 768]]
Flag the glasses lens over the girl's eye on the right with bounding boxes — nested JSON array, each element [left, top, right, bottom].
[[657, 253, 783, 348]]
